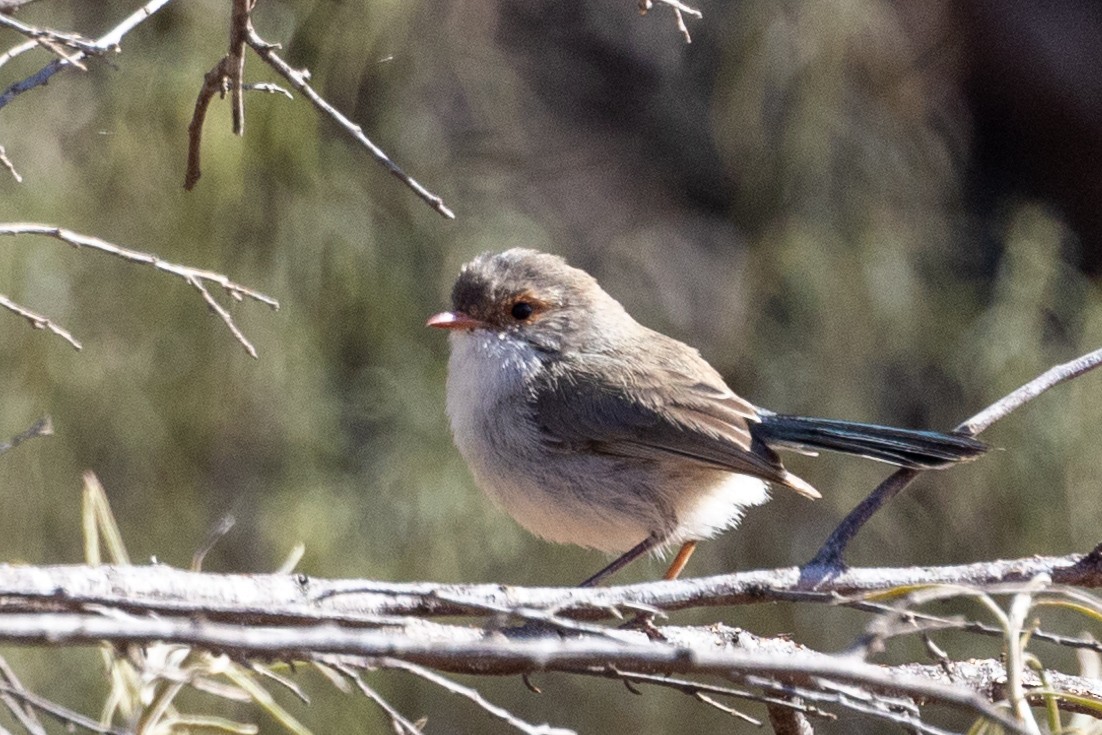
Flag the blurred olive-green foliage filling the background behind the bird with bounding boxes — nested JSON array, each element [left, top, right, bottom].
[[0, 0, 1102, 733]]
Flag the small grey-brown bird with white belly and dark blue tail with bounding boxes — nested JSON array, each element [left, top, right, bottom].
[[428, 248, 987, 586]]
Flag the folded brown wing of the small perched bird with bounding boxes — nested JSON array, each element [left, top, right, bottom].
[[532, 354, 818, 497]]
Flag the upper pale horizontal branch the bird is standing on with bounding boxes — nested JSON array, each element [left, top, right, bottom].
[[0, 550, 1102, 625]]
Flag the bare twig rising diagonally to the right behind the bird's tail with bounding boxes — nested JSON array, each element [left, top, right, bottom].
[[804, 349, 1102, 568]]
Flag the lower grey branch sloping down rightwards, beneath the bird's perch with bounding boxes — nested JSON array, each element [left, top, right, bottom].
[[0, 613, 1022, 732]]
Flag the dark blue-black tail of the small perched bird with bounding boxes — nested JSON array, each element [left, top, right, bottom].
[[750, 412, 988, 469]]
